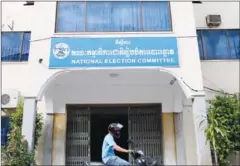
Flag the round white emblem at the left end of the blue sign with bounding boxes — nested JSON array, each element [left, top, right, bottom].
[[53, 43, 70, 59]]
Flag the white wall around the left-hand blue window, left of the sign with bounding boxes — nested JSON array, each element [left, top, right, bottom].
[[2, 2, 56, 95]]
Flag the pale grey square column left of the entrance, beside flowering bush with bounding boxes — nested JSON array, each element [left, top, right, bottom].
[[22, 97, 37, 151]]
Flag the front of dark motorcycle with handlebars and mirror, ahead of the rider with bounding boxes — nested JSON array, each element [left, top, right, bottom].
[[128, 140, 163, 166]]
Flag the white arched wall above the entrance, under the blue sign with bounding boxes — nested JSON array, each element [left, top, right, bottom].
[[41, 70, 183, 113]]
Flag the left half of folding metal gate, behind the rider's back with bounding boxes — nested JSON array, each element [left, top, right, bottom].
[[66, 107, 90, 166]]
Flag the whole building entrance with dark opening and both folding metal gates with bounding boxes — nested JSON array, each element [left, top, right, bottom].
[[66, 104, 162, 166]]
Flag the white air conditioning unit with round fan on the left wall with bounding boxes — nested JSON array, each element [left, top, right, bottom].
[[1, 90, 20, 109]]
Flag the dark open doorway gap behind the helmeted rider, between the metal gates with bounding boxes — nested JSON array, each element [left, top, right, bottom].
[[91, 107, 128, 162]]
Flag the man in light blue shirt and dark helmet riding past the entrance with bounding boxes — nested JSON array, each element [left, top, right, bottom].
[[102, 123, 131, 166]]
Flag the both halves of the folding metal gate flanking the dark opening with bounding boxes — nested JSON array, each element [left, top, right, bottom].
[[66, 105, 163, 166]]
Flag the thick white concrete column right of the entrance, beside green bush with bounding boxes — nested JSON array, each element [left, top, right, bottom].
[[182, 96, 212, 165]]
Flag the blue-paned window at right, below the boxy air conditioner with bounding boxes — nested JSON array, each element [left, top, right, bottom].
[[197, 29, 240, 60]]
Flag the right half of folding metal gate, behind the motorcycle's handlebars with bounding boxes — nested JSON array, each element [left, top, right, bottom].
[[128, 106, 162, 164]]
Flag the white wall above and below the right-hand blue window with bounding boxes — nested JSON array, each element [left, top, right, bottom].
[[193, 2, 240, 98]]
